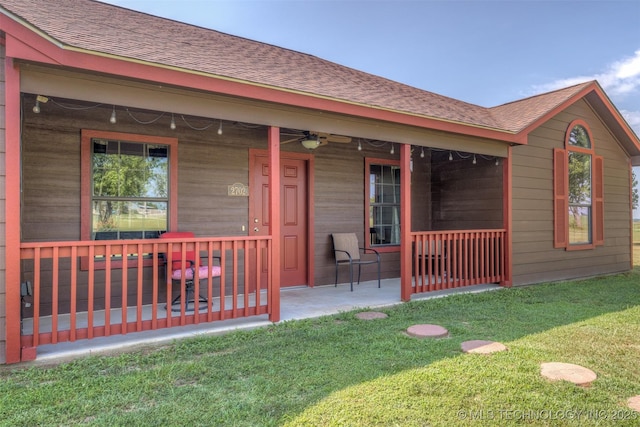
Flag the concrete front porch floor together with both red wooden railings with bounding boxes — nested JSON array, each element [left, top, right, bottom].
[[20, 230, 506, 360]]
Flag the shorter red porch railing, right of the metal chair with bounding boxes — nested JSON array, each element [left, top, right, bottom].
[[411, 230, 506, 293]]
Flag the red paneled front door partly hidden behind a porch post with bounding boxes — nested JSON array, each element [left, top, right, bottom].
[[249, 154, 308, 286]]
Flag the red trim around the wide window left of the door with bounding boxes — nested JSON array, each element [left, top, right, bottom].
[[80, 129, 178, 270]]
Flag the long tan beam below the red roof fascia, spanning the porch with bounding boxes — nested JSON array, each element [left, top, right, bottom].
[[21, 63, 508, 157]]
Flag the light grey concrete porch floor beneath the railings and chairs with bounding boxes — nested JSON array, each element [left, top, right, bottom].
[[36, 278, 501, 362]]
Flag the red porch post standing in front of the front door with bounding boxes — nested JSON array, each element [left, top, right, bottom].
[[268, 126, 282, 322]]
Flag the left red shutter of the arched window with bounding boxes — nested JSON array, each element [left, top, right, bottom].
[[553, 148, 569, 248]]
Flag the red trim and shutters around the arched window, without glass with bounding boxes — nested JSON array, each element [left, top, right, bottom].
[[553, 119, 604, 251]]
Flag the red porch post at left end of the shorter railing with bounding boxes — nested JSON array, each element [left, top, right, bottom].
[[400, 144, 411, 301]]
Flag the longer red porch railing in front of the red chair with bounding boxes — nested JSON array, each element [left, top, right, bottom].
[[20, 236, 272, 357]]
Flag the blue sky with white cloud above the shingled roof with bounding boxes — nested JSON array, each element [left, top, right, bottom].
[[100, 0, 640, 218]]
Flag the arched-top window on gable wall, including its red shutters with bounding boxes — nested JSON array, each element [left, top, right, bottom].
[[554, 120, 604, 250]]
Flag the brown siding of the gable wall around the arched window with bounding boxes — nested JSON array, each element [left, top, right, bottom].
[[512, 101, 631, 285]]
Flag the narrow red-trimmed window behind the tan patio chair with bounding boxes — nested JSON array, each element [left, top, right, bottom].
[[365, 159, 400, 249]]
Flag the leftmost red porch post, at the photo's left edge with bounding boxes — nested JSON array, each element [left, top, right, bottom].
[[0, 55, 22, 363]]
